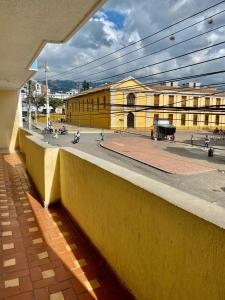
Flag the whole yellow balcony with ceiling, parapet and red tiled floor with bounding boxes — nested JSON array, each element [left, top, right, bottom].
[[0, 0, 225, 300]]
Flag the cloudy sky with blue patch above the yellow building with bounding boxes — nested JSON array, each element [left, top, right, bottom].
[[36, 0, 225, 84]]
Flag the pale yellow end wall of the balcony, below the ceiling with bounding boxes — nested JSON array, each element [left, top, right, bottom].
[[0, 90, 19, 151]]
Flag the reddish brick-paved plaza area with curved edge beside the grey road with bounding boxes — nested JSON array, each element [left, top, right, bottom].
[[101, 137, 215, 174]]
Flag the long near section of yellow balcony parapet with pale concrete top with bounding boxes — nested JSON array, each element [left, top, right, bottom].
[[60, 148, 225, 300]]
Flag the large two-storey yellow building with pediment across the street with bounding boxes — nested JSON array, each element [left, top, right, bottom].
[[66, 77, 225, 130]]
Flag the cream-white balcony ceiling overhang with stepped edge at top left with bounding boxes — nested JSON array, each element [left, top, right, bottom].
[[0, 0, 105, 89]]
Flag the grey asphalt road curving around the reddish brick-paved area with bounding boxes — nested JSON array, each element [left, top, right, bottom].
[[37, 129, 225, 207]]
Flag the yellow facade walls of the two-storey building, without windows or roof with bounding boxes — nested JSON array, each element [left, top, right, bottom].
[[67, 79, 225, 130]]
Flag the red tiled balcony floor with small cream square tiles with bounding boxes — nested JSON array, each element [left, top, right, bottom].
[[0, 154, 131, 300]]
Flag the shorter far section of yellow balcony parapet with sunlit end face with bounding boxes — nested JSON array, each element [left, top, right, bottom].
[[19, 129, 60, 206]]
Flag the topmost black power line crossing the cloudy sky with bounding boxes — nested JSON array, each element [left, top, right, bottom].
[[37, 0, 225, 77]]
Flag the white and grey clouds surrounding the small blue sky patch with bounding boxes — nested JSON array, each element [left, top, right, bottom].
[[35, 0, 225, 85]]
